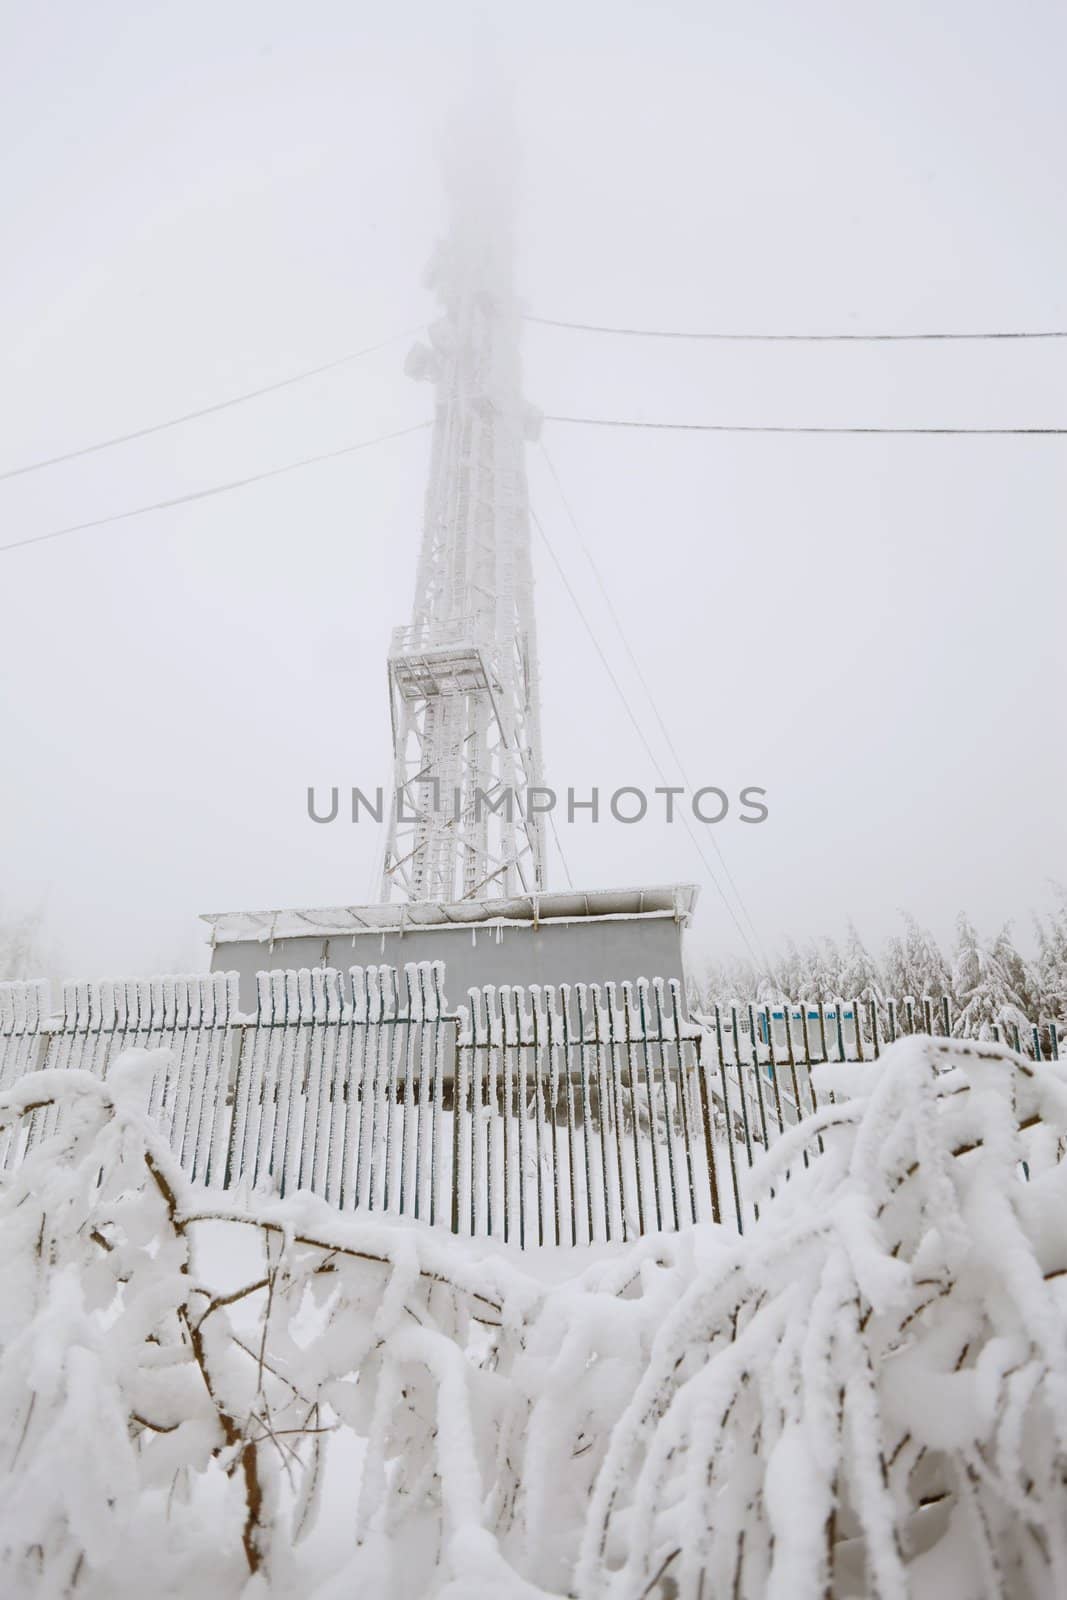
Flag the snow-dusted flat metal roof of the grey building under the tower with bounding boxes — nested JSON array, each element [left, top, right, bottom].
[[200, 883, 699, 944]]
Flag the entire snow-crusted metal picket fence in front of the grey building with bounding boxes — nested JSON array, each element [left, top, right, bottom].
[[0, 965, 1057, 1246]]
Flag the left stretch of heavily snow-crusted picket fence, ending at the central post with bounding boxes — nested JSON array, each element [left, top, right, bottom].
[[0, 965, 456, 1221]]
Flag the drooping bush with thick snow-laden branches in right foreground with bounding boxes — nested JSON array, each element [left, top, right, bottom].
[[576, 1038, 1067, 1600]]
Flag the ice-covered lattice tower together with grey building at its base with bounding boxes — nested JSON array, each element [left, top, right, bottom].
[[205, 109, 696, 1006]]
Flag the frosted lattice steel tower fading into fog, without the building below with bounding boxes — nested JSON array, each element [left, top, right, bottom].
[[382, 126, 544, 902]]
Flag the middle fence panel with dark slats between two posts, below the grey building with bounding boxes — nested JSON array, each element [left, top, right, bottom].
[[453, 979, 721, 1245]]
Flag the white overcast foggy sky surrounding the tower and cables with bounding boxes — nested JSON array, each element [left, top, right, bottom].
[[0, 0, 1067, 974]]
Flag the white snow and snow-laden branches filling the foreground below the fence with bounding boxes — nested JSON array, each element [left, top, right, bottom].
[[0, 1038, 1067, 1600]]
